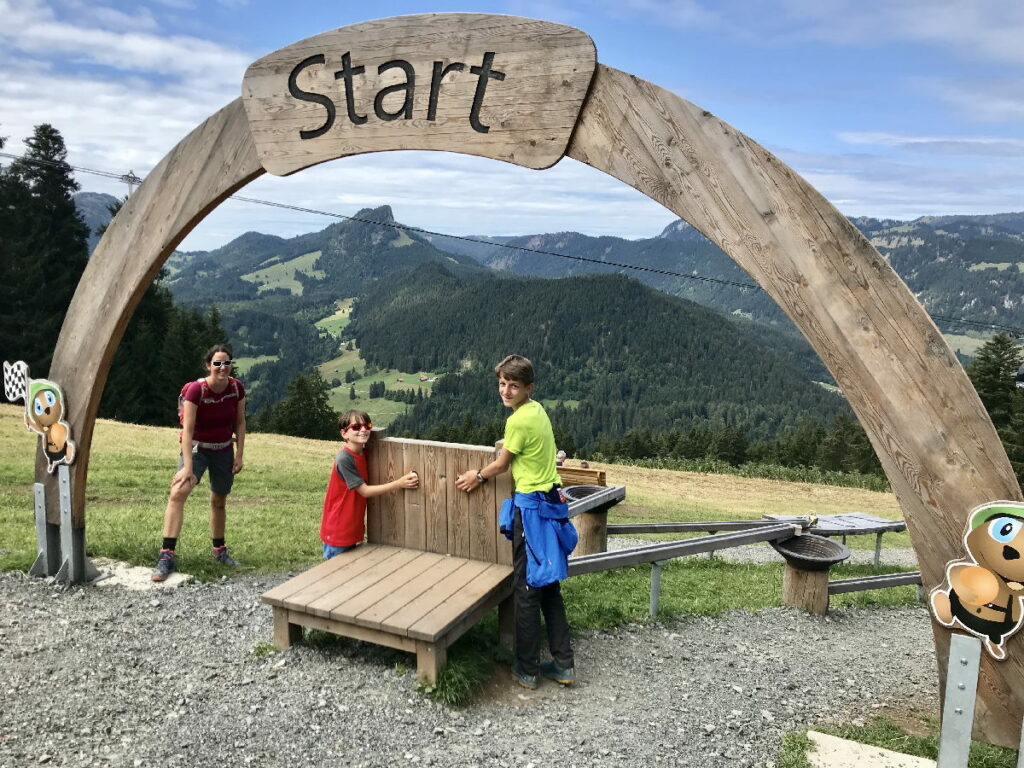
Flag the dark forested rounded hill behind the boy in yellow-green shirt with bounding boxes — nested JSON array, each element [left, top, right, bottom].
[[347, 264, 847, 452]]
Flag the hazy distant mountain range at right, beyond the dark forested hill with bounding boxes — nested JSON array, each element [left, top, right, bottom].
[[434, 213, 1024, 333]]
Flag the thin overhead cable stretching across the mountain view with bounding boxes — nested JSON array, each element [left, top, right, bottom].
[[6, 152, 1024, 337]]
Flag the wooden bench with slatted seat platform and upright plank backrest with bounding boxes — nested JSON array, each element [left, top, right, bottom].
[[262, 429, 512, 683]]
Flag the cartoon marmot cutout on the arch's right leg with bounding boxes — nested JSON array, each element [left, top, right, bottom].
[[931, 502, 1024, 659]]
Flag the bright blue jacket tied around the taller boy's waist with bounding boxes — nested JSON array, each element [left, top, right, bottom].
[[498, 490, 580, 587]]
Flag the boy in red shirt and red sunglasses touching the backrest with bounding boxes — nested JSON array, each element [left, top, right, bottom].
[[321, 411, 420, 560]]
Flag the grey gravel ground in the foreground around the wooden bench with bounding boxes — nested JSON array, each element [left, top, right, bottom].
[[0, 572, 937, 768]]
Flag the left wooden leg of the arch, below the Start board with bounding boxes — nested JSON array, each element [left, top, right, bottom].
[[36, 99, 263, 528]]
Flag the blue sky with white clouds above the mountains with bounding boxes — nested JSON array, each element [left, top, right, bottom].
[[0, 0, 1024, 250]]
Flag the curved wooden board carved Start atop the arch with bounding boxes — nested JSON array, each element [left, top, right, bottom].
[[242, 13, 596, 175]]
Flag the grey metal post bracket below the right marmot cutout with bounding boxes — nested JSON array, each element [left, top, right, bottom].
[[936, 634, 981, 768]]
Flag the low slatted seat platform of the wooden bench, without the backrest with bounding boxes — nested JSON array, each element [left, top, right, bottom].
[[262, 544, 512, 683]]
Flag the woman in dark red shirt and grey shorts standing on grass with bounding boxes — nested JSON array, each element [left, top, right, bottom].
[[153, 344, 246, 582]]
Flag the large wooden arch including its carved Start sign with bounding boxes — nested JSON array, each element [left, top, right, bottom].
[[46, 14, 1024, 746]]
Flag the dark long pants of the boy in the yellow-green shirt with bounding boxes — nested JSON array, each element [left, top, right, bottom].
[[512, 507, 574, 675]]
